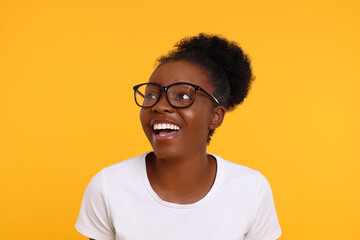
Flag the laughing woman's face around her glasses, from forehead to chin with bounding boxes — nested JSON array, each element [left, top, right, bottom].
[[140, 61, 222, 159]]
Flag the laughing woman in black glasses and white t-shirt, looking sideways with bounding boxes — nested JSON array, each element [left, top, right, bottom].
[[76, 34, 281, 240]]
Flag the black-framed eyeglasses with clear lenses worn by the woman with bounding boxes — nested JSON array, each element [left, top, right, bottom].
[[133, 82, 220, 108]]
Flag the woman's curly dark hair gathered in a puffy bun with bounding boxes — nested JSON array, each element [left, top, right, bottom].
[[157, 33, 254, 143]]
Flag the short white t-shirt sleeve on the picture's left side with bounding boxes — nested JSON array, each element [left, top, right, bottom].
[[75, 171, 115, 240]]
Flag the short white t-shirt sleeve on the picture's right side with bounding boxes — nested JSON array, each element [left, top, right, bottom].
[[244, 172, 281, 240]]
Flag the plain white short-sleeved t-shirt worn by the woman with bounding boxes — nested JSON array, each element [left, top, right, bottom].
[[75, 154, 281, 240]]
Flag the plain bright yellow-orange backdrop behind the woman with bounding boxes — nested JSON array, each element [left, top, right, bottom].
[[0, 0, 360, 240]]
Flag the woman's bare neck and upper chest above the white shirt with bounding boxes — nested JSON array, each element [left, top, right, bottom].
[[146, 150, 216, 203]]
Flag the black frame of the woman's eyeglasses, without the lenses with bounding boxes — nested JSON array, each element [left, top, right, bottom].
[[133, 82, 220, 108]]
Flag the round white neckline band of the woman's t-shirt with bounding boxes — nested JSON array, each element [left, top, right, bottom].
[[141, 152, 222, 209]]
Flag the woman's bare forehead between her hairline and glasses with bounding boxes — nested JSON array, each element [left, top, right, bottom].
[[149, 61, 212, 90]]
